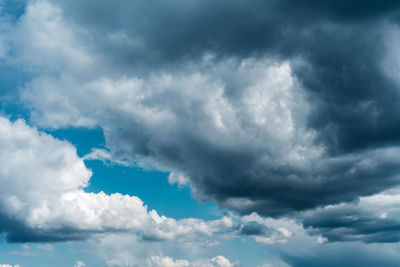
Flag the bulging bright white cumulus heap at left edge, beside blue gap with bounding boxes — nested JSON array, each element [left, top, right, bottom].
[[0, 117, 91, 226]]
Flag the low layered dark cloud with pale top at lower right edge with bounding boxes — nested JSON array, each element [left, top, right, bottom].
[[303, 190, 400, 243]]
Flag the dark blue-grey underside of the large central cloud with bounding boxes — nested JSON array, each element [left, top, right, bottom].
[[105, 119, 400, 216]]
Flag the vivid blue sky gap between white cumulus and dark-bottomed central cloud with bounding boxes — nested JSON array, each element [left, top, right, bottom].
[[47, 128, 222, 220]]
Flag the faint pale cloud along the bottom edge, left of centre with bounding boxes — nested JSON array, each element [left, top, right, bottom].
[[94, 233, 241, 267]]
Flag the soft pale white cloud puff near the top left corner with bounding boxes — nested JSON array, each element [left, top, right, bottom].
[[8, 1, 93, 74]]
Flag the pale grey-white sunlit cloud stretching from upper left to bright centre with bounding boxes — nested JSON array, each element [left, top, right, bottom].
[[11, 1, 323, 172]]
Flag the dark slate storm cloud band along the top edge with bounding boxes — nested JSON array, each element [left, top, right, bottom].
[[55, 0, 399, 67]]
